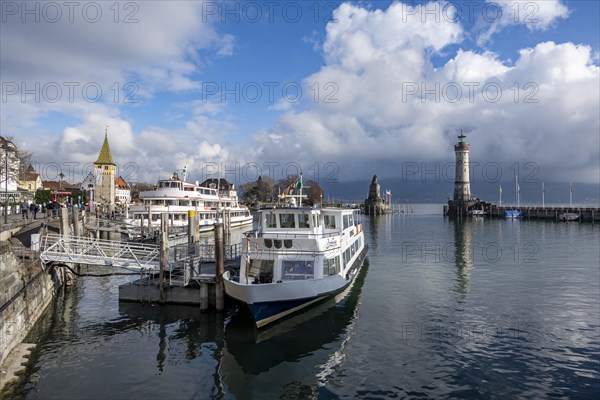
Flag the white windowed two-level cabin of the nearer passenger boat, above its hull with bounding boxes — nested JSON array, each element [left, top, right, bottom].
[[240, 208, 364, 284]]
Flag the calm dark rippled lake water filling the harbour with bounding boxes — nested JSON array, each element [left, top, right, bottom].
[[4, 205, 600, 400]]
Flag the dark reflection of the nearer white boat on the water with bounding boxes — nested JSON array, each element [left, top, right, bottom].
[[221, 263, 368, 398]]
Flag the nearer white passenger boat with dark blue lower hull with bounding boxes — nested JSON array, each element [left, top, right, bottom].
[[223, 186, 367, 328]]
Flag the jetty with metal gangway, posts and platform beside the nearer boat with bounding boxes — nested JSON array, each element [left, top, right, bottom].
[[40, 215, 241, 311]]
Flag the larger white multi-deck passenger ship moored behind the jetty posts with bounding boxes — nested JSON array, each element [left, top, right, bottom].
[[124, 170, 252, 236]]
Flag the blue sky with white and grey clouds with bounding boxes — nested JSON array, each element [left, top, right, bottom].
[[0, 0, 600, 188]]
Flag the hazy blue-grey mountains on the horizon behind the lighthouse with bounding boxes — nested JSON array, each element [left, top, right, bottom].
[[321, 178, 600, 207]]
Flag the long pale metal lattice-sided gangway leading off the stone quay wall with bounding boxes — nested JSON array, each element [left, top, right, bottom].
[[40, 233, 160, 273]]
